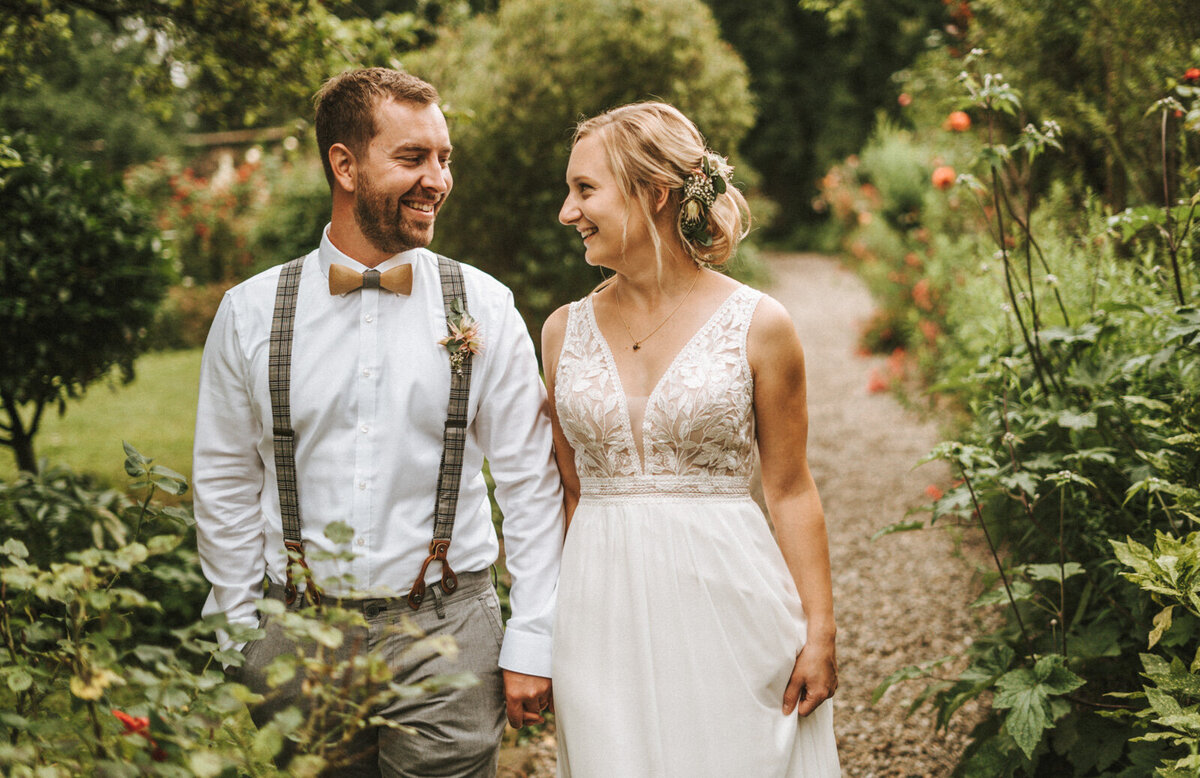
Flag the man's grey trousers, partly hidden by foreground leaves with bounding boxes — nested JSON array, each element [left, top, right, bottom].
[[238, 570, 505, 778]]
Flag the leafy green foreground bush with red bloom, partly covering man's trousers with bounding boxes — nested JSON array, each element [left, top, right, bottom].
[[0, 445, 475, 777]]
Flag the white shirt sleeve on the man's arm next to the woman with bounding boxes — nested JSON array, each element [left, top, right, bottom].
[[474, 288, 564, 677]]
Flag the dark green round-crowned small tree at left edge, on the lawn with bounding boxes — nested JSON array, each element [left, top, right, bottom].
[[0, 136, 167, 472]]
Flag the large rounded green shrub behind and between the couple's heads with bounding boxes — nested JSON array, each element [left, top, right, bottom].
[[406, 0, 754, 331]]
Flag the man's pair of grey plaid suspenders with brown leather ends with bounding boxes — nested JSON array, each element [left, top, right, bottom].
[[268, 256, 472, 610]]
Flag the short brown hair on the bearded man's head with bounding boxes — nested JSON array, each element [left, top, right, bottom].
[[314, 67, 439, 188]]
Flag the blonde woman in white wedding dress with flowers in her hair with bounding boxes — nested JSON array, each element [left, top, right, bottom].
[[542, 102, 840, 778]]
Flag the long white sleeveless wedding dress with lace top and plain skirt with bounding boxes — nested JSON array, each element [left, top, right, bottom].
[[553, 287, 840, 778]]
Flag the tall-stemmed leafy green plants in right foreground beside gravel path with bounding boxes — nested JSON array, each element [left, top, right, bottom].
[[876, 52, 1200, 778]]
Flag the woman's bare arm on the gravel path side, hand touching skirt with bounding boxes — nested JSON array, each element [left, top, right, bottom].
[[746, 297, 838, 716]]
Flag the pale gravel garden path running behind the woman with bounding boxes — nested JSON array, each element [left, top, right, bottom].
[[500, 255, 979, 778]]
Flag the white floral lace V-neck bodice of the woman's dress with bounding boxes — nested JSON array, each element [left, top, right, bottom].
[[554, 286, 762, 492]]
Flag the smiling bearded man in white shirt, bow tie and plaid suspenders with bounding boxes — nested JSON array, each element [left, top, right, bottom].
[[193, 68, 563, 776]]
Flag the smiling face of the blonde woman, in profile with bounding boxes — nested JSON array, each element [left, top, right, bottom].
[[558, 134, 649, 269]]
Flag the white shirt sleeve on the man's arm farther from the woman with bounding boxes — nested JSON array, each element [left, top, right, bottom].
[[192, 294, 266, 641]]
